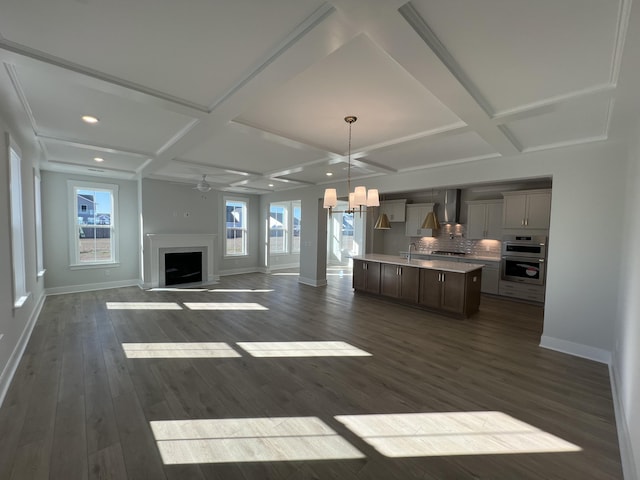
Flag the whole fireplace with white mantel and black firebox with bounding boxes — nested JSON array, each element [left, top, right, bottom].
[[144, 233, 217, 288]]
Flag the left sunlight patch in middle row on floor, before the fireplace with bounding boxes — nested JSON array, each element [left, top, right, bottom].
[[122, 342, 241, 358]]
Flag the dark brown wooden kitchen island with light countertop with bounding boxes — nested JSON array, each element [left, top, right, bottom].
[[353, 253, 482, 318]]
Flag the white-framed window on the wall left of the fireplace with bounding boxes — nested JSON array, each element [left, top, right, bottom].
[[68, 180, 118, 267]]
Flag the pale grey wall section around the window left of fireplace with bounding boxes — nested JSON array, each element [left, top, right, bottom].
[[42, 171, 140, 293]]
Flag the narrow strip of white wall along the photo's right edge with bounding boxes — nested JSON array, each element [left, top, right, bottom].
[[611, 121, 640, 480]]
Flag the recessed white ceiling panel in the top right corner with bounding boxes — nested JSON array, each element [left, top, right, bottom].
[[411, 0, 620, 112]]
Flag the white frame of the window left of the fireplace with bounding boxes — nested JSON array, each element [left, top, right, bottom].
[[67, 180, 120, 270]]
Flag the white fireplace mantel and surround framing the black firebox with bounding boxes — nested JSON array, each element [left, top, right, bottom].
[[145, 233, 217, 288]]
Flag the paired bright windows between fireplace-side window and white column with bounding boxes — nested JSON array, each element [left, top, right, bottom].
[[269, 200, 302, 254]]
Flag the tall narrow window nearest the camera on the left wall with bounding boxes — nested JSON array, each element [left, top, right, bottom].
[[7, 136, 29, 308]]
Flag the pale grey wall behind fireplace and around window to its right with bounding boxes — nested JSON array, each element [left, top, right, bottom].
[[142, 179, 264, 281]]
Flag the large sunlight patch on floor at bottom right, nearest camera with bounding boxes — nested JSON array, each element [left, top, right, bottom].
[[335, 412, 582, 457]]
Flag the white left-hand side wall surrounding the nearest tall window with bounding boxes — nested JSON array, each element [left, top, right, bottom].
[[0, 118, 44, 404]]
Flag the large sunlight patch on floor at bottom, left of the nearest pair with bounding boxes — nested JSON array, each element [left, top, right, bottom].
[[150, 417, 364, 465]]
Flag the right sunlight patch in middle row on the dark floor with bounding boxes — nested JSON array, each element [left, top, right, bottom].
[[237, 342, 371, 357]]
